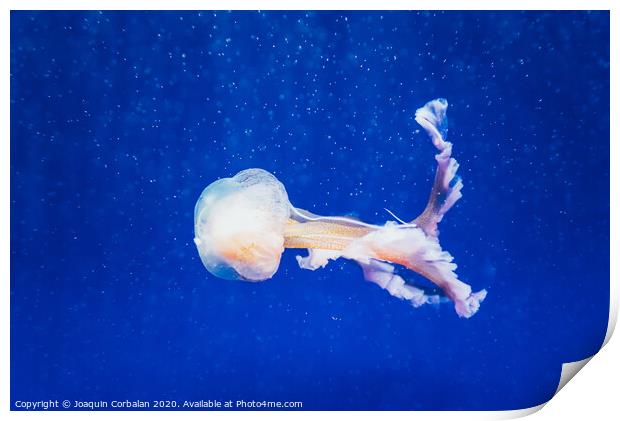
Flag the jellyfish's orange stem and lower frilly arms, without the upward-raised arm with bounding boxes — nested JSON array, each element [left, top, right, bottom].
[[284, 218, 486, 317]]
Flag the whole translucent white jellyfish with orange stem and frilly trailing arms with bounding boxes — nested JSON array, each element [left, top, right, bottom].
[[194, 98, 487, 318]]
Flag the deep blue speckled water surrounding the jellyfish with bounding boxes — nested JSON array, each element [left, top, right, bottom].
[[10, 11, 610, 409]]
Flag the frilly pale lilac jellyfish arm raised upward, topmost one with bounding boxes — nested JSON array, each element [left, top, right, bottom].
[[412, 98, 463, 237]]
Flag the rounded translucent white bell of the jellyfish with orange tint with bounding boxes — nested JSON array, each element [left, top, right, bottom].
[[194, 168, 291, 281]]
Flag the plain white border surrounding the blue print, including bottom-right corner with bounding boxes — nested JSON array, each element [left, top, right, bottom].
[[0, 0, 620, 420]]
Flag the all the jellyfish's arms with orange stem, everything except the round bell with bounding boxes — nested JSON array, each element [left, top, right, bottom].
[[284, 99, 487, 317]]
